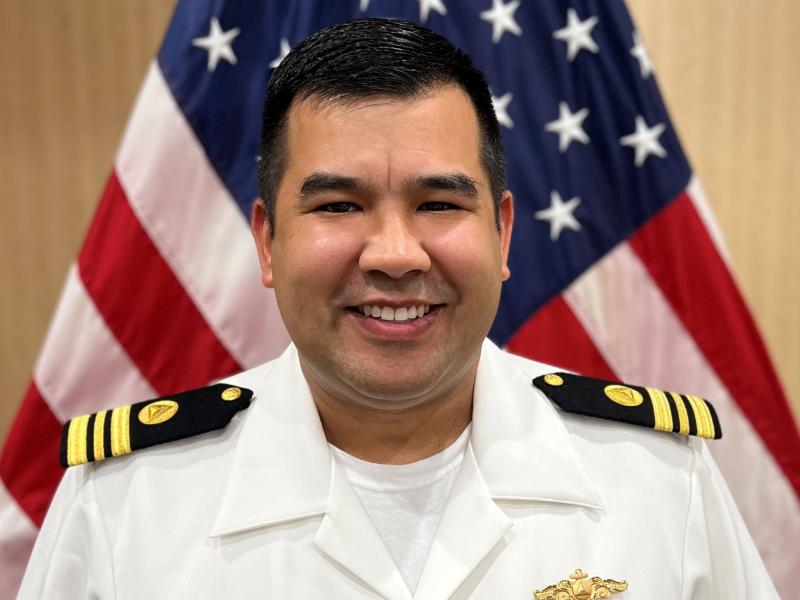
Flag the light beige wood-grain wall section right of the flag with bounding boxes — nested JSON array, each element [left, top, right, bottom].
[[629, 0, 800, 419]]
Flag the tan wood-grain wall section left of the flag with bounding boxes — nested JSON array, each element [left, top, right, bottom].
[[0, 0, 172, 440]]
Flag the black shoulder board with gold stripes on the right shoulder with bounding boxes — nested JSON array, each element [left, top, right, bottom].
[[533, 373, 722, 440]]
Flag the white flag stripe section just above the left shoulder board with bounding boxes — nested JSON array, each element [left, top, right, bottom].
[[33, 265, 156, 423]]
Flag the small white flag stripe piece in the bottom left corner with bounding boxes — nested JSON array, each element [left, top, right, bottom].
[[0, 480, 38, 599]]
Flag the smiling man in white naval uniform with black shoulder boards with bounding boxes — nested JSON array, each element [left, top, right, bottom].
[[20, 20, 777, 600]]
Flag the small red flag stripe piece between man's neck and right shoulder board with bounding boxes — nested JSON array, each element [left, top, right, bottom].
[[508, 296, 616, 379]]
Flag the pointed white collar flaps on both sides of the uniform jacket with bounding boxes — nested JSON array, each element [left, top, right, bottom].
[[210, 340, 602, 537]]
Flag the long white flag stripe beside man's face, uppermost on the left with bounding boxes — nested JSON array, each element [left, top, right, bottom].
[[116, 63, 289, 368]]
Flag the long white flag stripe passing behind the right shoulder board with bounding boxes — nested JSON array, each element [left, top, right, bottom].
[[564, 238, 800, 589]]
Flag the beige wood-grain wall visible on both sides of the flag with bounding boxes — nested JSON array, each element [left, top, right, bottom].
[[0, 0, 800, 439]]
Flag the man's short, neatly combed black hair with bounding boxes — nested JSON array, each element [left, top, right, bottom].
[[257, 18, 506, 235]]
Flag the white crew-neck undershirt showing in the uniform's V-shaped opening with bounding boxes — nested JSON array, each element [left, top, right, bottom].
[[331, 427, 470, 594]]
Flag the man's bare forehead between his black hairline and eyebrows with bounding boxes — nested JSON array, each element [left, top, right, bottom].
[[286, 85, 486, 187]]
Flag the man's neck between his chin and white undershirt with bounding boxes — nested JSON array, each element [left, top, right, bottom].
[[306, 364, 477, 465]]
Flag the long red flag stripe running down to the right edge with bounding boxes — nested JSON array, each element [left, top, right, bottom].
[[629, 193, 800, 495]]
